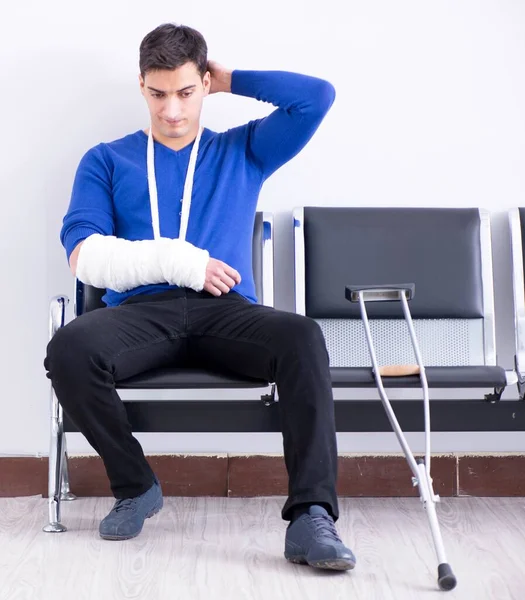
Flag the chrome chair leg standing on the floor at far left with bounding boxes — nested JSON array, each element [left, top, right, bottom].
[[43, 388, 67, 533]]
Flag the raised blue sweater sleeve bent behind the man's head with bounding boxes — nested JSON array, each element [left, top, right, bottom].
[[231, 70, 335, 178]]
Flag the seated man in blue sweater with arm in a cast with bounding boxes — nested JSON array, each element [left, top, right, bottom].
[[45, 24, 355, 570]]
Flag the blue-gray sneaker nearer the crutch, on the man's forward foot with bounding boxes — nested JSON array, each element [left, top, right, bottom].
[[284, 505, 356, 571]]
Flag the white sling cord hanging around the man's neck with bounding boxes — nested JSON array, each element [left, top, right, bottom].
[[147, 126, 203, 241]]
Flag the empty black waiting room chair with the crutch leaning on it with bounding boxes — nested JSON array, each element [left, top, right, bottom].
[[293, 207, 512, 402]]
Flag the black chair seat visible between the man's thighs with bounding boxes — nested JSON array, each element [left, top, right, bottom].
[[117, 368, 269, 390]]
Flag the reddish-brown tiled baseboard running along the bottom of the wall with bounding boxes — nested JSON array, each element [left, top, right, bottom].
[[0, 454, 525, 497]]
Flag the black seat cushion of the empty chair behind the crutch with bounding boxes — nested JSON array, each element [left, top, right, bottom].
[[330, 366, 507, 388]]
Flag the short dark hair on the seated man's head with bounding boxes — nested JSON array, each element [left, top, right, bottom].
[[139, 23, 208, 77]]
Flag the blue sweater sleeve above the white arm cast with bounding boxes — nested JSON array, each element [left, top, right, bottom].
[[60, 144, 115, 260]]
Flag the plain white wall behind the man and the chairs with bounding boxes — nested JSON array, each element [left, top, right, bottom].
[[0, 0, 525, 455]]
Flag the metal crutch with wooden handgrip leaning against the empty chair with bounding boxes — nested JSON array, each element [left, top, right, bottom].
[[345, 284, 457, 591]]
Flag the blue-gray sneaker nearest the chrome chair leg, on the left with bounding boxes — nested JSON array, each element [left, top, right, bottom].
[[98, 477, 163, 540]]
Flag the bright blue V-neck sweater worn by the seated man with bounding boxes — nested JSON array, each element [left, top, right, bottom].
[[60, 70, 335, 306]]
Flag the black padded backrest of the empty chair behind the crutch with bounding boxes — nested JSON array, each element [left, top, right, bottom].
[[304, 207, 484, 319]]
